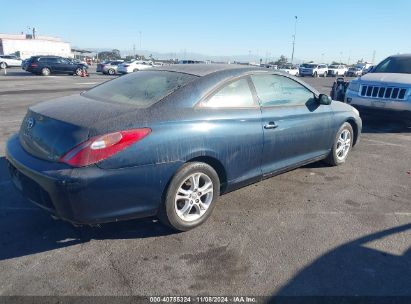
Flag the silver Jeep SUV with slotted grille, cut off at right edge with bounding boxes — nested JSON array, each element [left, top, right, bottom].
[[345, 54, 411, 119]]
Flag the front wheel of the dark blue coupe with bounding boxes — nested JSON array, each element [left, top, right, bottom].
[[325, 122, 354, 166]]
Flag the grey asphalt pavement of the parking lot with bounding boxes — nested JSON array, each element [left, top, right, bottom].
[[0, 70, 411, 296]]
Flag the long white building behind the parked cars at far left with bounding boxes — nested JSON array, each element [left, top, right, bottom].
[[0, 33, 73, 59]]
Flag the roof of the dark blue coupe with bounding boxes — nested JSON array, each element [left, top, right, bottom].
[[154, 64, 267, 77]]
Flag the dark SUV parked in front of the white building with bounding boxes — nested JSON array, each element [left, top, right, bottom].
[[26, 56, 87, 76]]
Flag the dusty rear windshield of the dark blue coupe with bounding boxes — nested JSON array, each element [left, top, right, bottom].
[[83, 71, 197, 107]]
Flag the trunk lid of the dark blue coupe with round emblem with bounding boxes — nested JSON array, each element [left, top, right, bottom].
[[19, 95, 140, 161]]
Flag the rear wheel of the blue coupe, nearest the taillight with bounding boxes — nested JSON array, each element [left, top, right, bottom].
[[158, 162, 220, 231]]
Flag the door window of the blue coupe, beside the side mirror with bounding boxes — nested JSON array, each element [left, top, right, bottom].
[[251, 75, 314, 107]]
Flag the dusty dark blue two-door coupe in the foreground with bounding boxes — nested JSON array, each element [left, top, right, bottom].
[[6, 64, 362, 231]]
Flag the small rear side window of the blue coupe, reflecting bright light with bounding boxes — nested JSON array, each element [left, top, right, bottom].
[[201, 78, 255, 108]]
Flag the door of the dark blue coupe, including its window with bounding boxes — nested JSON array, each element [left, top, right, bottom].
[[251, 74, 333, 176]]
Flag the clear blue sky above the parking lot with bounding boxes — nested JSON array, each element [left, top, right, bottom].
[[0, 0, 411, 62]]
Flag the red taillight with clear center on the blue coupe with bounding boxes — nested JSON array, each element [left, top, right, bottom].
[[60, 128, 151, 167]]
